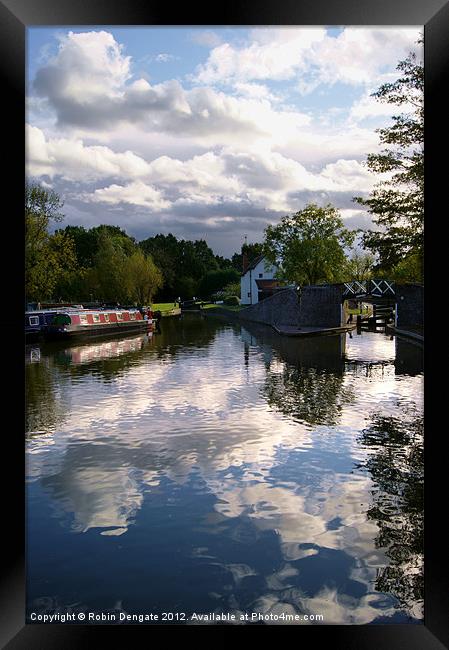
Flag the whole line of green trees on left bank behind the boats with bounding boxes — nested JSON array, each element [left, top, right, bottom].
[[25, 181, 241, 304]]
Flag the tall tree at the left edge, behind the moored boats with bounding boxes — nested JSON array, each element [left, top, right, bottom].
[[25, 182, 76, 301]]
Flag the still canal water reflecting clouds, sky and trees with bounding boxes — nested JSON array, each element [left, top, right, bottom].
[[26, 314, 423, 624]]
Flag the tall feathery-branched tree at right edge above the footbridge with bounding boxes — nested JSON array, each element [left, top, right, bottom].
[[354, 39, 424, 272]]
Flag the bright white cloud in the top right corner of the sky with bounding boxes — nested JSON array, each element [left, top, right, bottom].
[[195, 27, 419, 93]]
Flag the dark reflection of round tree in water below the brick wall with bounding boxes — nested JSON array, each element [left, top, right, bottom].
[[262, 365, 354, 425]]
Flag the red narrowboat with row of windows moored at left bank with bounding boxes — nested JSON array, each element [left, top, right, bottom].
[[45, 309, 153, 339]]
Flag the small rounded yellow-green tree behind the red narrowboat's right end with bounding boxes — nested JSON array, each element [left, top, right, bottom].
[[124, 250, 163, 305]]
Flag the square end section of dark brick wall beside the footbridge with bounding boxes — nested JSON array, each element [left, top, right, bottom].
[[299, 284, 346, 327]]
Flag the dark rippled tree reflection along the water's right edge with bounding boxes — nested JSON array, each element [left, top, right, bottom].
[[361, 408, 424, 609]]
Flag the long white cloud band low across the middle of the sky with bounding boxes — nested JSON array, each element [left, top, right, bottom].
[[27, 126, 382, 223]]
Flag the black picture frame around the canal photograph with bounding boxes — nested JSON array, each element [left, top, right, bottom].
[[0, 0, 449, 650]]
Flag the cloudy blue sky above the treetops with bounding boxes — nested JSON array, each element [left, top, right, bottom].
[[26, 25, 423, 257]]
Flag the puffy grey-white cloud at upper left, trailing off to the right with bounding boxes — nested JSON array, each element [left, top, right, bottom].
[[34, 32, 310, 142]]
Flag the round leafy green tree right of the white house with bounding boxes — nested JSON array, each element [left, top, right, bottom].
[[264, 203, 355, 285]]
